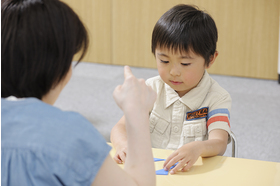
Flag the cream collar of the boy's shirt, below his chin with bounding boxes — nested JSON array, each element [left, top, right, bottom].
[[165, 70, 211, 110]]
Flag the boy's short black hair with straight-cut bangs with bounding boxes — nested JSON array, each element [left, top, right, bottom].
[[152, 4, 218, 66]]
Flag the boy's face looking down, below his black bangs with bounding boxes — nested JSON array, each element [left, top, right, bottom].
[[155, 48, 216, 97]]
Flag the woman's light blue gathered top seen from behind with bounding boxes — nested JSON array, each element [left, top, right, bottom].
[[1, 97, 111, 185]]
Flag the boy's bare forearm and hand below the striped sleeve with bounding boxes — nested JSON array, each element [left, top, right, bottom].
[[163, 129, 228, 174]]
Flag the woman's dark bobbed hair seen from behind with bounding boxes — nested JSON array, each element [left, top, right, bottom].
[[1, 0, 89, 99]]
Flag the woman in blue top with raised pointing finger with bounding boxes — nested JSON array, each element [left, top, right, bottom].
[[1, 0, 156, 185]]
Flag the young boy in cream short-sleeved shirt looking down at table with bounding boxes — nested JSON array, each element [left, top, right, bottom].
[[111, 5, 231, 174]]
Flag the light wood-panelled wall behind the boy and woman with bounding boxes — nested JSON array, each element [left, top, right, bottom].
[[64, 0, 280, 79]]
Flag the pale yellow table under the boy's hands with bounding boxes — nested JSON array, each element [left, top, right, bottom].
[[110, 145, 280, 186]]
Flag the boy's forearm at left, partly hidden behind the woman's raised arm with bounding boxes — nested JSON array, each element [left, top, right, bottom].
[[111, 116, 127, 163]]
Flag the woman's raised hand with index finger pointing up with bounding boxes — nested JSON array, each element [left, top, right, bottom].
[[113, 66, 156, 114]]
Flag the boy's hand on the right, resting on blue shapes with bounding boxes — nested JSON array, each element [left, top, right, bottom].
[[163, 141, 201, 174]]
